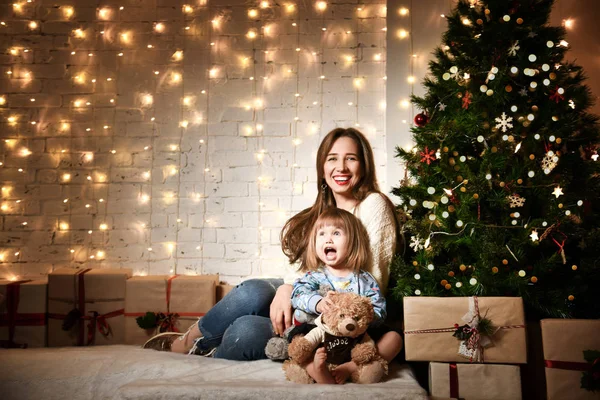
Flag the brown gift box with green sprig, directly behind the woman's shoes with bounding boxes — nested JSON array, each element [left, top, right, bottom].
[[125, 275, 219, 345]]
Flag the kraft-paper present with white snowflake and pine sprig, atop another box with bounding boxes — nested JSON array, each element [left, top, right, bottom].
[[404, 297, 527, 364]]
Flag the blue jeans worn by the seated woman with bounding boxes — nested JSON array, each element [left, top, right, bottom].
[[198, 279, 283, 360]]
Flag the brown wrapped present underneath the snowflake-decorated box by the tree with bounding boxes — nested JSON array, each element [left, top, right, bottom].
[[429, 362, 521, 400]]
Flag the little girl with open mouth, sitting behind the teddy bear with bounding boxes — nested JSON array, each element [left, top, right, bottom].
[[292, 207, 386, 383]]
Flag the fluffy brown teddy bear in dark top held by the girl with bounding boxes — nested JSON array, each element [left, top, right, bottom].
[[283, 293, 388, 383]]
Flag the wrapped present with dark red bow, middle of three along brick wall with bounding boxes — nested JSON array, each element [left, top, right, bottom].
[[48, 268, 131, 347]]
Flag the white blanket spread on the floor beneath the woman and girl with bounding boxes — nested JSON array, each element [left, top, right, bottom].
[[0, 346, 427, 400]]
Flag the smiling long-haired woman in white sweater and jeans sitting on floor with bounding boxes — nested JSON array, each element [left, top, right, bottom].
[[144, 128, 402, 366]]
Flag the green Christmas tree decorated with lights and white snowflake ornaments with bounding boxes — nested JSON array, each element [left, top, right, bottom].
[[392, 0, 600, 318]]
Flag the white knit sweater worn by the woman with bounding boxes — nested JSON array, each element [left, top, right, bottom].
[[284, 193, 396, 295]]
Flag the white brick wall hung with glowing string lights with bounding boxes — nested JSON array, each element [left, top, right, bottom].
[[0, 0, 386, 282]]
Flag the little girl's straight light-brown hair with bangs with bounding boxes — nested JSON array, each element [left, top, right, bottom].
[[305, 207, 372, 272]]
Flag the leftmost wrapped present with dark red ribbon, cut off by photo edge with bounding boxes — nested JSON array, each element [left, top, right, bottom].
[[0, 279, 48, 348]]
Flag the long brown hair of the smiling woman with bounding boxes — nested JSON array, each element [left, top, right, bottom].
[[279, 128, 398, 270]]
